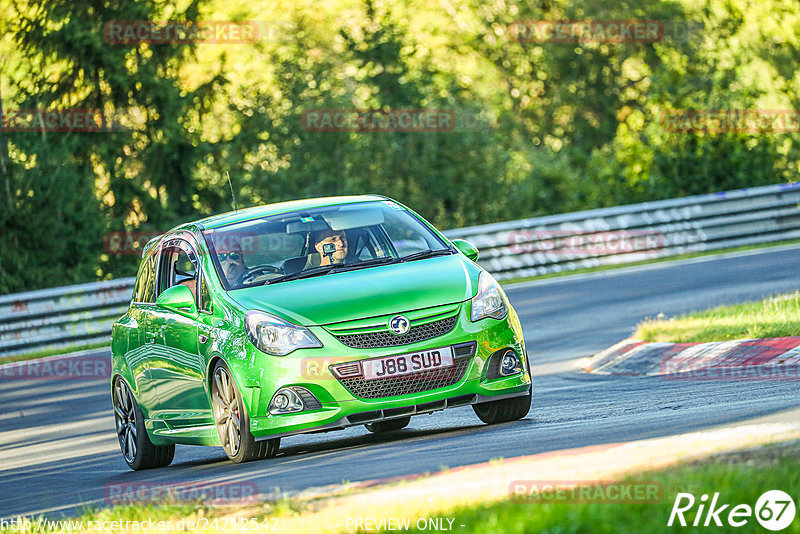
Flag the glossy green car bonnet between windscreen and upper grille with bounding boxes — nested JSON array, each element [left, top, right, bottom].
[[228, 254, 480, 326]]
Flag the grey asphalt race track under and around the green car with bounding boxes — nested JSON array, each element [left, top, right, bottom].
[[0, 247, 800, 518]]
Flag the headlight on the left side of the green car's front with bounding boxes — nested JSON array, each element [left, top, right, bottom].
[[245, 310, 322, 356]]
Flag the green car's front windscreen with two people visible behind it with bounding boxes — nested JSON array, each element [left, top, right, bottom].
[[203, 200, 453, 290]]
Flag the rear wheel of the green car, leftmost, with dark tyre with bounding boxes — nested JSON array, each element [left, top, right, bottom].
[[111, 378, 175, 471]]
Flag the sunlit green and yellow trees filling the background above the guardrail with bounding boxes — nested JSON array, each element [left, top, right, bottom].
[[0, 0, 800, 293]]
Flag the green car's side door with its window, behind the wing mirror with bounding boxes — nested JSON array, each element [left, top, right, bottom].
[[148, 239, 212, 428]]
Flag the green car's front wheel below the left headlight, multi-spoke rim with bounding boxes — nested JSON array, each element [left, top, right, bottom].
[[211, 360, 281, 464]]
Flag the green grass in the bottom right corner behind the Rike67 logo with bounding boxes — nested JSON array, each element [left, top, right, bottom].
[[404, 443, 800, 534]]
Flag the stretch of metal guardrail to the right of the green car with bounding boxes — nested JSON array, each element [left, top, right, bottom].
[[445, 182, 800, 280]]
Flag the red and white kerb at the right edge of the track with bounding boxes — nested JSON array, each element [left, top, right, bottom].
[[579, 337, 800, 380]]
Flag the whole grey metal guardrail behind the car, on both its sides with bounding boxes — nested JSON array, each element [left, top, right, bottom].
[[0, 183, 800, 358]]
